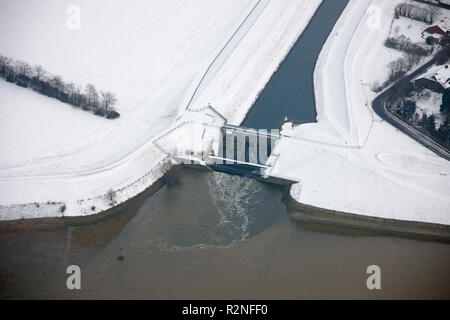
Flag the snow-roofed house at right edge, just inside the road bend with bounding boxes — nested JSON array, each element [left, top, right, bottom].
[[412, 64, 450, 92]]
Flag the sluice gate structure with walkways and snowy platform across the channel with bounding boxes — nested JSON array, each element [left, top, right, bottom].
[[153, 105, 296, 184]]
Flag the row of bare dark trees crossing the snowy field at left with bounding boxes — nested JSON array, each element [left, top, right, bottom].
[[0, 55, 120, 119]]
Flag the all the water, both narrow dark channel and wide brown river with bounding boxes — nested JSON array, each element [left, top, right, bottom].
[[0, 0, 450, 299]]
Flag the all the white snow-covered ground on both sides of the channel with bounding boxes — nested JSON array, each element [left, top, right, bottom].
[[0, 0, 450, 225]]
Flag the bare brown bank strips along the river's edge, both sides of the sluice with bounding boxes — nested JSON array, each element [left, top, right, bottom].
[[0, 165, 450, 243]]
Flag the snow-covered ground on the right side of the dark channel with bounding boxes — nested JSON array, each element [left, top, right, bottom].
[[271, 0, 450, 225]]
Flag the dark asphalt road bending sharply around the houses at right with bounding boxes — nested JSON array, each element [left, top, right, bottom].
[[372, 59, 450, 161]]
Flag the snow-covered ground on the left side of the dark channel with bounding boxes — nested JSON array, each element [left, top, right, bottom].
[[0, 0, 320, 220]]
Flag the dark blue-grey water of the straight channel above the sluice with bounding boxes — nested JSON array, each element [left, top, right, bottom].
[[243, 0, 348, 129]]
